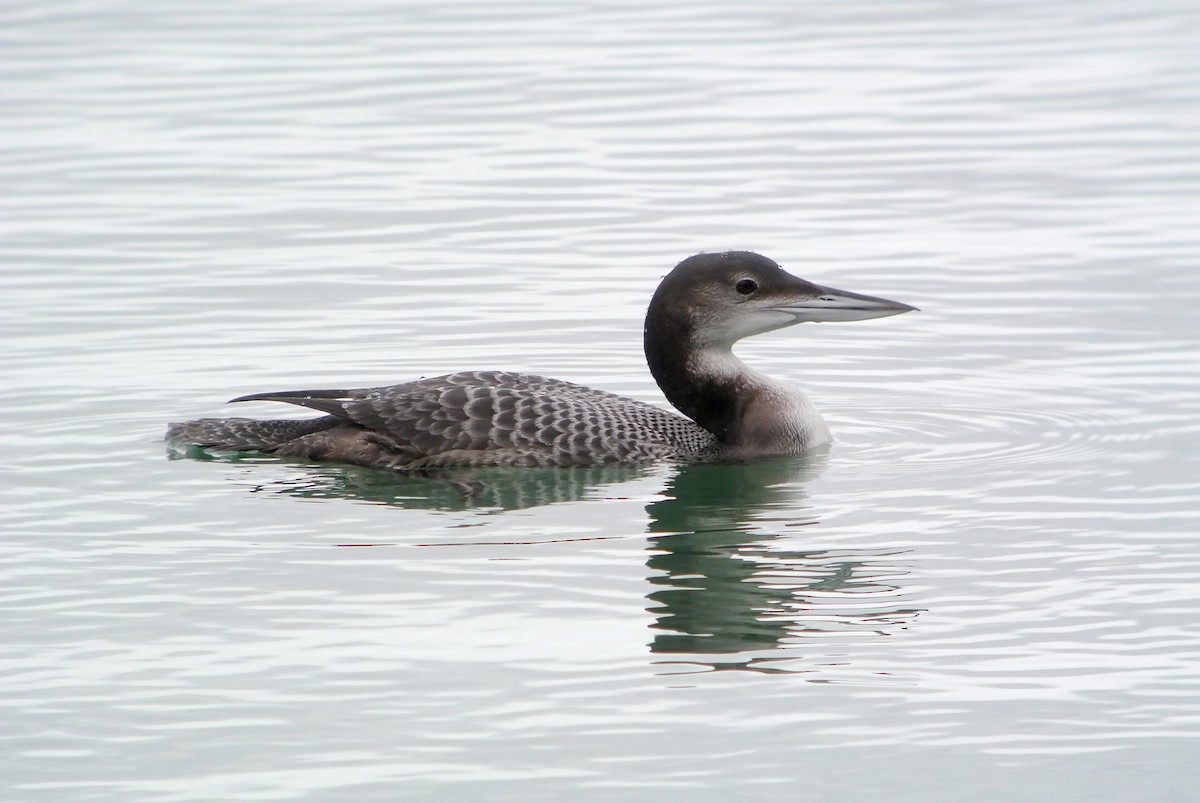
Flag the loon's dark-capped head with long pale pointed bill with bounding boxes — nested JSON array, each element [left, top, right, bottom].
[[646, 251, 917, 350]]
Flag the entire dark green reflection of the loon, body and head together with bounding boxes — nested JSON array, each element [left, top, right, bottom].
[[177, 444, 919, 672]]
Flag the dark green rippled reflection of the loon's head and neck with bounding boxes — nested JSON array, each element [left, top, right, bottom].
[[647, 455, 917, 670]]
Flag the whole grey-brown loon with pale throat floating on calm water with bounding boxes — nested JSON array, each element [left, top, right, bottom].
[[167, 251, 916, 471]]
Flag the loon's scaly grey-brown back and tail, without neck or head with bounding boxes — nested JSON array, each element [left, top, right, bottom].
[[168, 371, 715, 469]]
